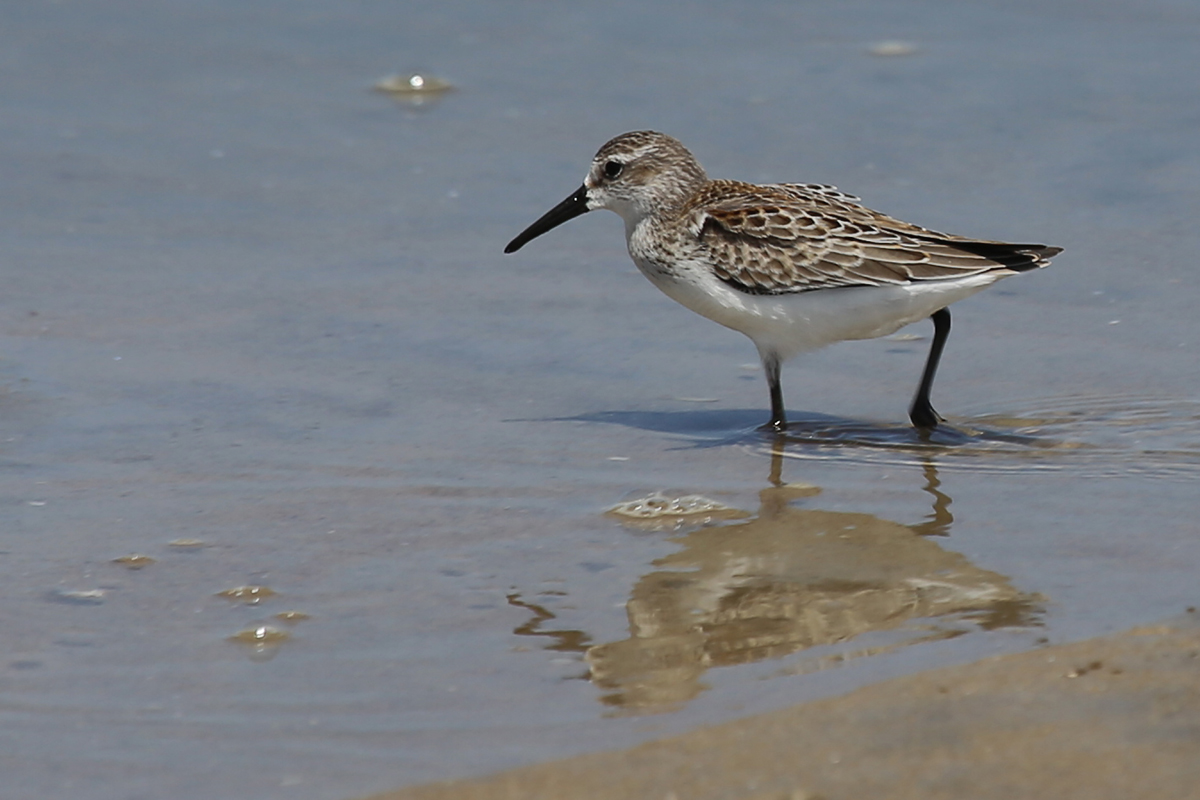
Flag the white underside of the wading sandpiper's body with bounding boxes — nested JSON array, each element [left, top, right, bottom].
[[634, 251, 1014, 361]]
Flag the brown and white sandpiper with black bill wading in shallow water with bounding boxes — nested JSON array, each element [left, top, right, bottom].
[[504, 131, 1062, 431]]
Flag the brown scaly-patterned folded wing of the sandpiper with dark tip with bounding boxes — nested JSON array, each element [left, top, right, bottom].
[[684, 181, 1058, 294]]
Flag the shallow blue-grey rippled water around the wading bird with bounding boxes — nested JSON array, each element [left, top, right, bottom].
[[0, 2, 1200, 800]]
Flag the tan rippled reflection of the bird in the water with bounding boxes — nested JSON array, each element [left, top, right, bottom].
[[509, 443, 1043, 714]]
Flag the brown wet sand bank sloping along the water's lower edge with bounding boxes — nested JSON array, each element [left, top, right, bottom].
[[371, 612, 1200, 800]]
